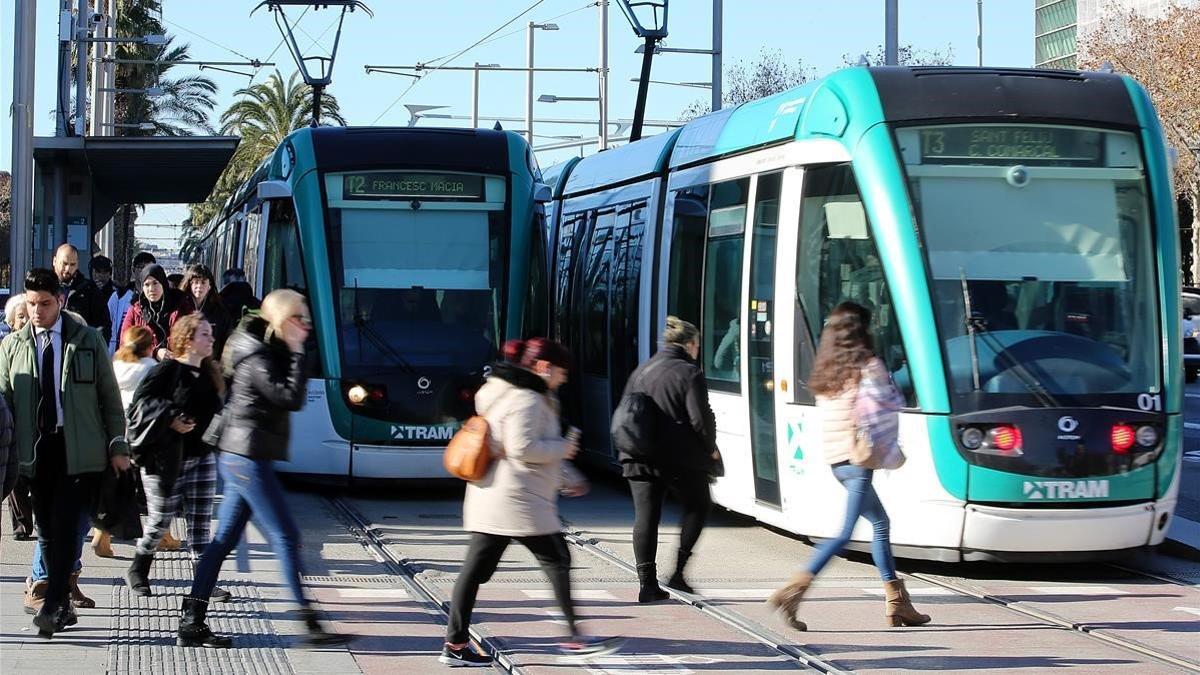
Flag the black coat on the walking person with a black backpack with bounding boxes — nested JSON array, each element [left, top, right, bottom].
[[620, 345, 716, 478]]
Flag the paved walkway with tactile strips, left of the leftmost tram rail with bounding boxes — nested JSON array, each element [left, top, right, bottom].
[[0, 494, 444, 675]]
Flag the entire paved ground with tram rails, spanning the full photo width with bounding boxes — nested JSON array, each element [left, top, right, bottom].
[[0, 480, 1200, 675]]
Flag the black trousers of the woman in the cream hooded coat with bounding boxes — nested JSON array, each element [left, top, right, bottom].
[[446, 532, 575, 645]]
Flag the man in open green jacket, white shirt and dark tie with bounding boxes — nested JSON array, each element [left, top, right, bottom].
[[0, 269, 130, 638]]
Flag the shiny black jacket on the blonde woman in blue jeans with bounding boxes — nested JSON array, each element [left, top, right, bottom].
[[218, 317, 307, 460]]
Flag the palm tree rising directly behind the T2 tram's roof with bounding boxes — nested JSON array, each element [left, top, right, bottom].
[[185, 71, 346, 241]]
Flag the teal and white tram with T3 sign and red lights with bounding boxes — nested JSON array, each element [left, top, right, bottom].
[[551, 67, 1183, 560]]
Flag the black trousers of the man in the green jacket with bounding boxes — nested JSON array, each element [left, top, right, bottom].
[[30, 431, 100, 610]]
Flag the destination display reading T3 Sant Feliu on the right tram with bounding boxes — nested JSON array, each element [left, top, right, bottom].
[[920, 125, 1104, 166]]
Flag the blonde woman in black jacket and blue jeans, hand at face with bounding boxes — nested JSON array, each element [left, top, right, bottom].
[[176, 288, 348, 647]]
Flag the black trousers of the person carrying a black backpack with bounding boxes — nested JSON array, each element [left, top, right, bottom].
[[629, 472, 713, 572]]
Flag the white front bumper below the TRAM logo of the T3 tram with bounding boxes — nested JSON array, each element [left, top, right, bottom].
[[962, 501, 1175, 560]]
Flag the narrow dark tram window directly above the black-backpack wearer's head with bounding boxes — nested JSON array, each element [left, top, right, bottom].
[[667, 185, 708, 325]]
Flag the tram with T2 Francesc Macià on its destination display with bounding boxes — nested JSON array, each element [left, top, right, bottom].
[[202, 127, 550, 482]]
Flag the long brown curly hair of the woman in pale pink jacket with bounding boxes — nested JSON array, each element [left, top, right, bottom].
[[809, 303, 875, 396]]
